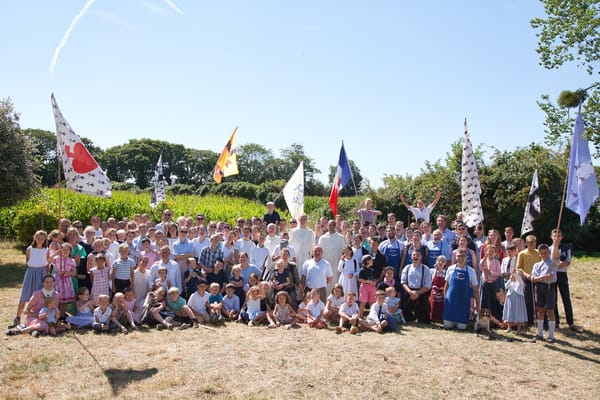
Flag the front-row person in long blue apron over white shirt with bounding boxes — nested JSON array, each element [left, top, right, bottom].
[[442, 248, 479, 329]]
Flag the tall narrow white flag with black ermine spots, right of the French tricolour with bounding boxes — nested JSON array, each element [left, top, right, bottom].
[[461, 118, 483, 228]]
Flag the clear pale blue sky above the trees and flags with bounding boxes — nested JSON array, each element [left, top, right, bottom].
[[0, 0, 589, 187]]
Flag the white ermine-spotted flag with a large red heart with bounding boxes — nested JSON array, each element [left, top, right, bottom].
[[50, 94, 112, 198]]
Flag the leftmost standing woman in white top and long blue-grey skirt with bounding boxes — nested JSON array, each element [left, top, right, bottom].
[[9, 231, 48, 328]]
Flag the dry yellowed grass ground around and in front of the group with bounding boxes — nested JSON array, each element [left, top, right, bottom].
[[0, 243, 600, 399]]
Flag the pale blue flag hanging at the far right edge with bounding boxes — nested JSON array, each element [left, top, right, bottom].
[[565, 105, 598, 225]]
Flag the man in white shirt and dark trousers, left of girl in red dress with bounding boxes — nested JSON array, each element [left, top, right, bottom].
[[400, 250, 431, 324]]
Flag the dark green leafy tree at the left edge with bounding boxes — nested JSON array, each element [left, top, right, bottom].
[[0, 99, 37, 206]]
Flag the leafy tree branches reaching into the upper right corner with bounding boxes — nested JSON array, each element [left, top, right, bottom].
[[531, 0, 600, 154]]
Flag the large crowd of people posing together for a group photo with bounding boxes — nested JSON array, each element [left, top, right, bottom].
[[7, 192, 577, 342]]
